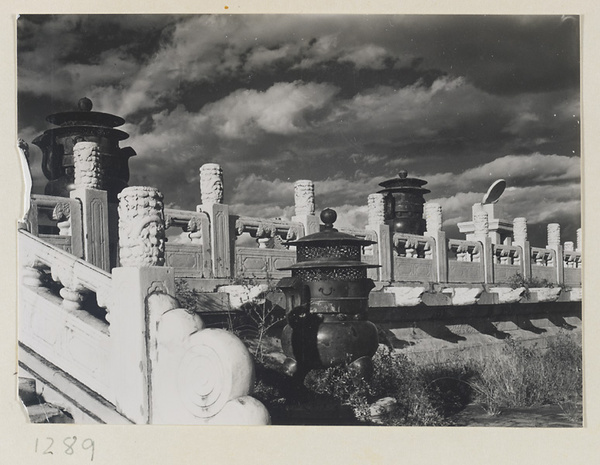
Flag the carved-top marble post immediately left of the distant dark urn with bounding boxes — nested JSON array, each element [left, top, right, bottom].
[[366, 193, 394, 281]]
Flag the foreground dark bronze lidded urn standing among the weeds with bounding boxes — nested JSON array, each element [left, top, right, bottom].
[[277, 209, 379, 378]]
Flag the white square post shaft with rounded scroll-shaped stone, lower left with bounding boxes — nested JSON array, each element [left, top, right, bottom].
[[110, 267, 270, 425]]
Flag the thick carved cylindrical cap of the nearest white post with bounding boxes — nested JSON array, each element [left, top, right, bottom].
[[118, 186, 165, 268]]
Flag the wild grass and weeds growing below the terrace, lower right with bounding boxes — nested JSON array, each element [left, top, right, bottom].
[[254, 332, 582, 426]]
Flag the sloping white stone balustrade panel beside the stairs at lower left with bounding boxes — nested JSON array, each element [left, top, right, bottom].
[[19, 231, 112, 401]]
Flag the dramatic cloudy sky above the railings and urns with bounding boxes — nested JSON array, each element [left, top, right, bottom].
[[17, 15, 581, 245]]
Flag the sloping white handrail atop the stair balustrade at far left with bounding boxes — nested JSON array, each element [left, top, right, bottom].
[[19, 231, 111, 310]]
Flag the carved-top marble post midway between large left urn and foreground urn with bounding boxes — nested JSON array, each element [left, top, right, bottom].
[[196, 163, 232, 278]]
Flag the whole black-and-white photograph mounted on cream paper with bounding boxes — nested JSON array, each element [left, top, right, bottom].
[[15, 10, 594, 432]]
